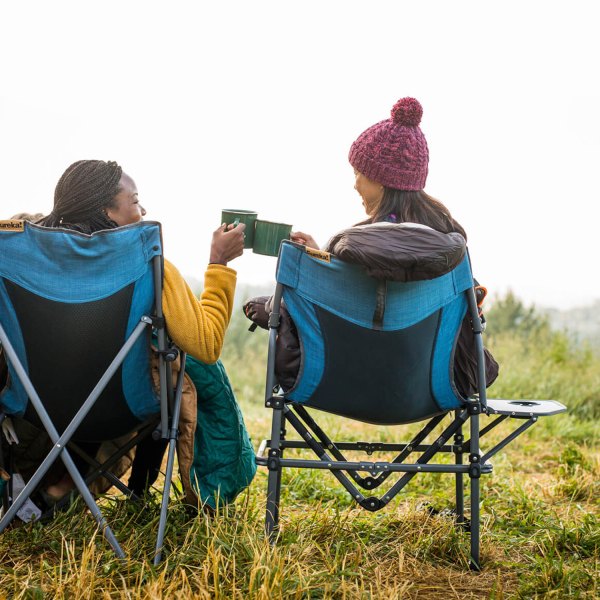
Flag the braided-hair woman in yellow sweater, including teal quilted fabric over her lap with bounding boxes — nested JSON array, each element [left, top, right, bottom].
[[30, 160, 256, 506]]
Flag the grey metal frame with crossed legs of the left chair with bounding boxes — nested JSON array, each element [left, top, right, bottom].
[[0, 230, 186, 565]]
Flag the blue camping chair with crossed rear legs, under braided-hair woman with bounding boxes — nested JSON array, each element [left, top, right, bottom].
[[0, 221, 185, 564]]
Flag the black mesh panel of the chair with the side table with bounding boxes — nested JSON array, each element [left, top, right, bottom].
[[306, 306, 443, 424]]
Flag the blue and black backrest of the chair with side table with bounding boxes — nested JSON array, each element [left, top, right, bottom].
[[276, 242, 473, 424]]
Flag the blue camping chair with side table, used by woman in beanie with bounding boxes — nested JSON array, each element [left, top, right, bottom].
[[257, 242, 565, 570]]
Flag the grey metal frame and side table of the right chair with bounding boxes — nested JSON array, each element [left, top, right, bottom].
[[256, 251, 566, 571]]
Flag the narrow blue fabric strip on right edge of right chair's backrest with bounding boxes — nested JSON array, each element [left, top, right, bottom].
[[431, 293, 467, 410]]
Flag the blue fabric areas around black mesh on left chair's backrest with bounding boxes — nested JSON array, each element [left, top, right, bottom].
[[0, 221, 162, 419]]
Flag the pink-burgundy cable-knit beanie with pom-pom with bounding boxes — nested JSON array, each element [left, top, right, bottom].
[[348, 98, 429, 190]]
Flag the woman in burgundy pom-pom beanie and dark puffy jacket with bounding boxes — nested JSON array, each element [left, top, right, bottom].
[[244, 98, 498, 397]]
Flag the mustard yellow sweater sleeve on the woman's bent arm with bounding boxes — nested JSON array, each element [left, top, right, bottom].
[[163, 260, 236, 363]]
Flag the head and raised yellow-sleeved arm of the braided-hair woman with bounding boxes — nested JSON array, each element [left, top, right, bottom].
[[38, 160, 244, 363]]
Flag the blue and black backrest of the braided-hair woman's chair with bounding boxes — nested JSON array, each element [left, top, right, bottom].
[[0, 222, 162, 441]]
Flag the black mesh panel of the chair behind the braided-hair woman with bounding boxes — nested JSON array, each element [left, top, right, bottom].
[[4, 280, 138, 441]]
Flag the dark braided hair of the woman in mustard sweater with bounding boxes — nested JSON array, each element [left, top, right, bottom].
[[39, 160, 123, 233]]
